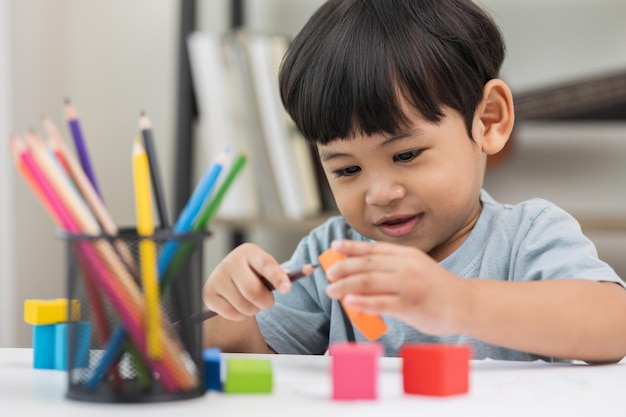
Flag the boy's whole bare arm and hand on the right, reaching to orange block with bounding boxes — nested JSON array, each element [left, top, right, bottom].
[[327, 241, 626, 363]]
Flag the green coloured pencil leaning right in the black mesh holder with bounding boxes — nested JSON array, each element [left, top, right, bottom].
[[161, 152, 248, 291]]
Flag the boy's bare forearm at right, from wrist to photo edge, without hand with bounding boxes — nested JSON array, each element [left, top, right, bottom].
[[457, 279, 626, 363]]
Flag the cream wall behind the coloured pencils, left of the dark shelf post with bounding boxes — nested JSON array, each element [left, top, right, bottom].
[[6, 0, 179, 346]]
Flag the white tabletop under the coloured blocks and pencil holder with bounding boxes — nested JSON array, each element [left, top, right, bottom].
[[0, 348, 626, 417]]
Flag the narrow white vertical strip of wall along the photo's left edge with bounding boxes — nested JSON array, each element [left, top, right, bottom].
[[0, 0, 18, 346]]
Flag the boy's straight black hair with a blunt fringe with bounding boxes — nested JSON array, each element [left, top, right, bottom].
[[279, 0, 505, 144]]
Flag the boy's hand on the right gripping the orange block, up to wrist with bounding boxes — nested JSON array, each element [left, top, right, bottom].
[[326, 240, 470, 335]]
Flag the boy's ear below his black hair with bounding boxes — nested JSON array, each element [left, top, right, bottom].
[[472, 78, 515, 155]]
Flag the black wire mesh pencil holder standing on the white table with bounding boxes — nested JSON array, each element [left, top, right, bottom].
[[55, 229, 208, 402]]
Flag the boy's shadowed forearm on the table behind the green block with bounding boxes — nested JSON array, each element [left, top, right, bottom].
[[203, 316, 276, 353]]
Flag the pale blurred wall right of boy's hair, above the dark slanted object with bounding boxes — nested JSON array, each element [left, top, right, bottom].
[[480, 0, 626, 90]]
